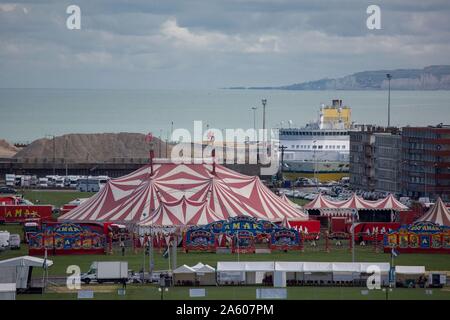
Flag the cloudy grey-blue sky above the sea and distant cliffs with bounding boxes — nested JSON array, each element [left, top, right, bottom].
[[0, 0, 450, 89]]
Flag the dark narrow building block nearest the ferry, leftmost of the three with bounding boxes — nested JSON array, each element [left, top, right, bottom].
[[350, 125, 398, 191]]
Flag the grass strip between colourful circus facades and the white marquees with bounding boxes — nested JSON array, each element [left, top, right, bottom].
[[0, 234, 450, 276]]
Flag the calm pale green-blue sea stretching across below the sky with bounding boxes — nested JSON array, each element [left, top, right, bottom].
[[0, 89, 450, 143]]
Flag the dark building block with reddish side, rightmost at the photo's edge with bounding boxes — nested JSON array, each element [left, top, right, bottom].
[[402, 124, 450, 201]]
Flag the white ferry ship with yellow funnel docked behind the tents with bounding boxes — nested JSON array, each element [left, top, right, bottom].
[[279, 99, 356, 181]]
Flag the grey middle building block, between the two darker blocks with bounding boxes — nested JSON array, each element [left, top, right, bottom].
[[374, 131, 402, 194]]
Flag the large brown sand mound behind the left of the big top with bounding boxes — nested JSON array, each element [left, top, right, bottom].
[[14, 133, 170, 163]]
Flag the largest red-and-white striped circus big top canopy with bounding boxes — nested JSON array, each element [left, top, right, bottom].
[[58, 163, 307, 225]]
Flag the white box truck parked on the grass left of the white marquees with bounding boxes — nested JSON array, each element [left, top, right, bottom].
[[81, 261, 128, 284]]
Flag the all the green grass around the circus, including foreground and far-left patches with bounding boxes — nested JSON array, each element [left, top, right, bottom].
[[0, 191, 450, 299]]
